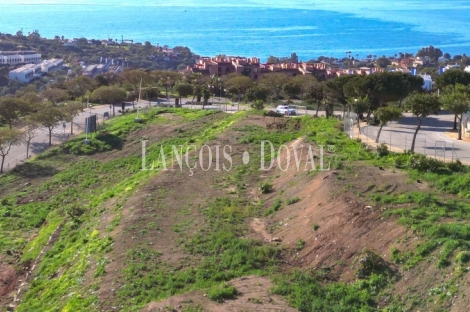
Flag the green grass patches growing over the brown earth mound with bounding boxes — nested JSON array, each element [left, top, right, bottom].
[[0, 109, 470, 311]]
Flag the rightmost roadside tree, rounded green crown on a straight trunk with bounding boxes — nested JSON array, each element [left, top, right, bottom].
[[441, 84, 470, 140]]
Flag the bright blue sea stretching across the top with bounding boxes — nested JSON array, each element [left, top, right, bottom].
[[0, 0, 470, 61]]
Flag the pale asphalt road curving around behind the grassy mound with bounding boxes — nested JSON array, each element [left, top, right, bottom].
[[4, 97, 470, 171]]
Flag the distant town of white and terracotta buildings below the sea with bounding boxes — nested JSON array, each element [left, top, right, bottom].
[[0, 34, 470, 90]]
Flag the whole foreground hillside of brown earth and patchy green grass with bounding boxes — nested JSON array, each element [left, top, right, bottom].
[[0, 109, 470, 312]]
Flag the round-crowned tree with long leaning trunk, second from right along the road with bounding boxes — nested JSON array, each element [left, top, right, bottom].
[[405, 93, 440, 152]]
